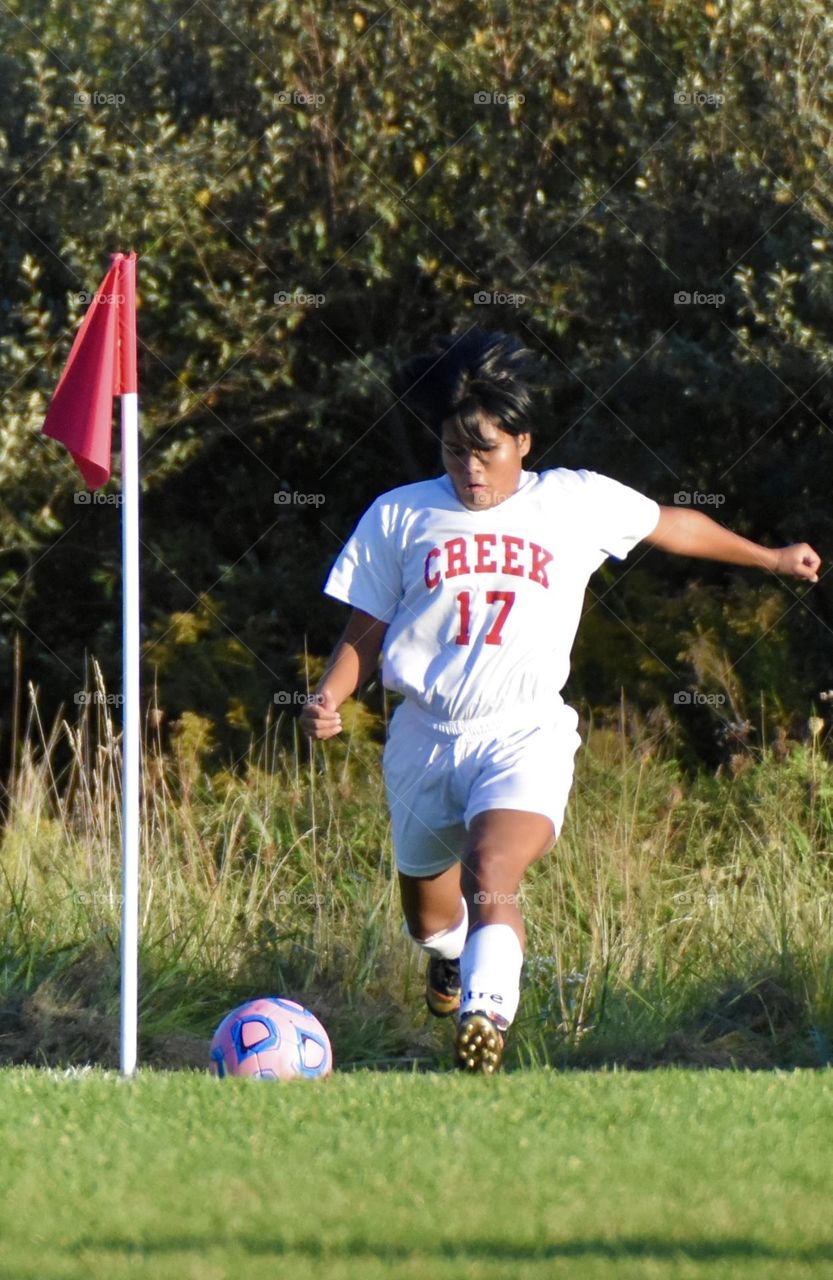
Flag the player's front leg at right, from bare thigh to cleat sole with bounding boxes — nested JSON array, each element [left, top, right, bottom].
[[457, 809, 555, 1071]]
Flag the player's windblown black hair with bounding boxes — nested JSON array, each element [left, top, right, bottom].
[[394, 325, 539, 451]]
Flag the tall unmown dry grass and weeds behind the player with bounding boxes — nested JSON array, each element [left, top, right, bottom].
[[0, 677, 833, 1066]]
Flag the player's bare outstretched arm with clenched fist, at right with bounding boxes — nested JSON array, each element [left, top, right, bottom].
[[645, 507, 821, 582]]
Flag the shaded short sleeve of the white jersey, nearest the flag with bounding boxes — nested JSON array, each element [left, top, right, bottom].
[[324, 497, 403, 622]]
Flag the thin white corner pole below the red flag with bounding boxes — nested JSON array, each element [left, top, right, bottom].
[[120, 392, 141, 1075]]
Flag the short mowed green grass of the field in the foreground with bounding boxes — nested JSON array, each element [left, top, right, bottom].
[[0, 1068, 833, 1280]]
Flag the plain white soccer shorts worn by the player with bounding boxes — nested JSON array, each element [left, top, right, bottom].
[[383, 700, 581, 877]]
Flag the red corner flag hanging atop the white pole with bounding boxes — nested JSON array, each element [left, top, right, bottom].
[[44, 253, 137, 489]]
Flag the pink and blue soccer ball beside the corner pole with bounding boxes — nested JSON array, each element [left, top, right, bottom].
[[209, 996, 333, 1080]]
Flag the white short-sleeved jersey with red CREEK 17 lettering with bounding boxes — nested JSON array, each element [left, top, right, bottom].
[[324, 467, 659, 721]]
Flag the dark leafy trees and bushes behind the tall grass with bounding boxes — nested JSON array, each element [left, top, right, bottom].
[[0, 0, 833, 760]]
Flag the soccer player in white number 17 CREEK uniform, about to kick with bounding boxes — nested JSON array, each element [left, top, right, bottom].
[[301, 328, 820, 1073]]
